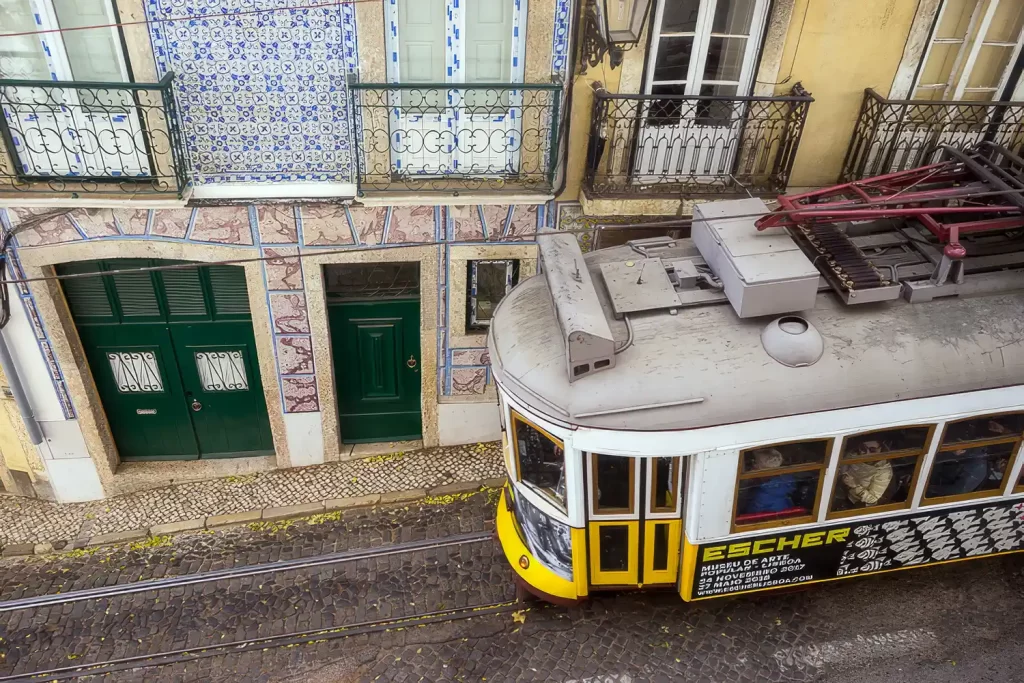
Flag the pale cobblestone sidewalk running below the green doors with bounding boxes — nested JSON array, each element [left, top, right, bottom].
[[0, 442, 504, 554]]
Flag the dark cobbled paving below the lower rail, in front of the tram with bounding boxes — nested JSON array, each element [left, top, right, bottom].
[[58, 557, 1024, 683]]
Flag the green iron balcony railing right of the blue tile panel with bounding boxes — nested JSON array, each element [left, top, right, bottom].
[[350, 83, 561, 195]]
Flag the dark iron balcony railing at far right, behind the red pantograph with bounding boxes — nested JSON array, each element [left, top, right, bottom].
[[840, 88, 1024, 182]]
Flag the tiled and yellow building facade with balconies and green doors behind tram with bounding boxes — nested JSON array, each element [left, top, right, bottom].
[[0, 0, 1022, 501]]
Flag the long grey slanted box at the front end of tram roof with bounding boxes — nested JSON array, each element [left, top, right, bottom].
[[537, 232, 614, 382]]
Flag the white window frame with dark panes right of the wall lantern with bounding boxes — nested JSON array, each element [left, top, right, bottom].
[[644, 0, 770, 97]]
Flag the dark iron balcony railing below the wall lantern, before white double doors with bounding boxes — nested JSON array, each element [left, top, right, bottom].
[[584, 84, 814, 198]]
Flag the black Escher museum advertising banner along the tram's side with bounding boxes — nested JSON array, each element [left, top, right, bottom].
[[692, 500, 1024, 599]]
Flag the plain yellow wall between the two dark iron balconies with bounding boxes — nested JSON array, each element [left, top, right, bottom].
[[775, 0, 919, 187]]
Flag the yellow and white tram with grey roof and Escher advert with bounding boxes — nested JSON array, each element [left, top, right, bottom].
[[488, 200, 1024, 602]]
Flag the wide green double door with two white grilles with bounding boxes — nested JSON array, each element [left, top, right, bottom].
[[57, 259, 273, 461]]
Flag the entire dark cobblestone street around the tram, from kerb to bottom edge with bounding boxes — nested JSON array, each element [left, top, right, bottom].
[[0, 492, 1024, 683]]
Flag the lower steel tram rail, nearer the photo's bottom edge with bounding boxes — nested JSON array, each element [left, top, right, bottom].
[[0, 600, 529, 683]]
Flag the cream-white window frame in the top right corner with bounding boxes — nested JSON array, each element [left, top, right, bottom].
[[909, 0, 1024, 101]]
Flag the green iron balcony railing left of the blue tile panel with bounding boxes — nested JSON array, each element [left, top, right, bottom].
[[0, 73, 189, 197]]
